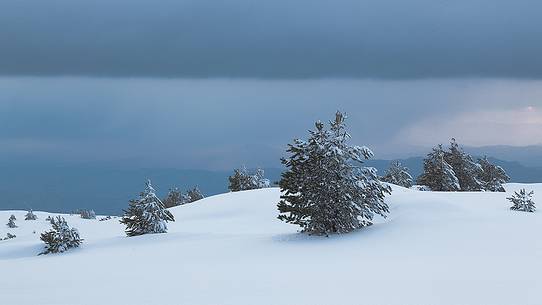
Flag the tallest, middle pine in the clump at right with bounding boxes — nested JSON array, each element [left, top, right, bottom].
[[444, 138, 483, 192]]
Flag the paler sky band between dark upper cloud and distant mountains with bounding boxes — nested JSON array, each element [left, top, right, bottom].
[[0, 78, 542, 169]]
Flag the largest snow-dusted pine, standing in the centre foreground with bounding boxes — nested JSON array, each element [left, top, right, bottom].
[[278, 112, 391, 235]]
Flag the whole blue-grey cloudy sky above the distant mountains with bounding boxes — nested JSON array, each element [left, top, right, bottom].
[[0, 0, 542, 169]]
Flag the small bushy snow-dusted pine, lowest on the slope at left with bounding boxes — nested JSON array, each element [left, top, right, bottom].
[[40, 216, 83, 255]]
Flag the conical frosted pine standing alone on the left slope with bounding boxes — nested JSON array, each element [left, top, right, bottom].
[[120, 180, 175, 236]]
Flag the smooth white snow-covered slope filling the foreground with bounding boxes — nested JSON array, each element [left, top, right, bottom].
[[0, 184, 542, 305]]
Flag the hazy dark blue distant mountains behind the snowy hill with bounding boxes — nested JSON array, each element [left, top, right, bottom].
[[0, 157, 542, 215]]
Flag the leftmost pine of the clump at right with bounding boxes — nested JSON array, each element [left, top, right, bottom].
[[417, 145, 461, 192]]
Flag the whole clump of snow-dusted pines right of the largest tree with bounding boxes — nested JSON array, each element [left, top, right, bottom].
[[417, 139, 510, 192]]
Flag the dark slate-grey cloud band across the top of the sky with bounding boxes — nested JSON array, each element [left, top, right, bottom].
[[0, 0, 542, 78]]
